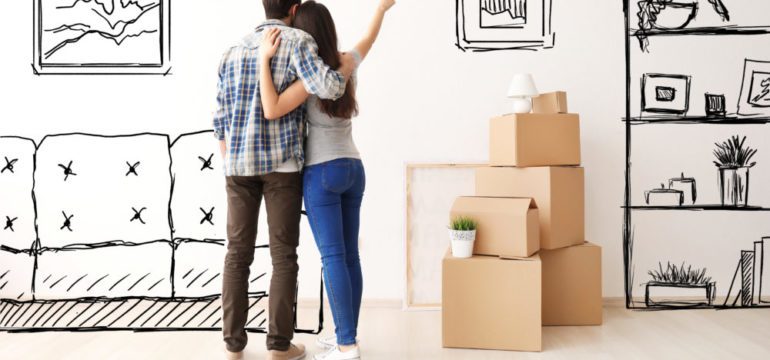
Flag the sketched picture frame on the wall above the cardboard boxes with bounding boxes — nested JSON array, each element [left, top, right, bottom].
[[456, 0, 556, 52]]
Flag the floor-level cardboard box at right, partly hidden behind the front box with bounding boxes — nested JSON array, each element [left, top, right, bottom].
[[539, 243, 602, 326]]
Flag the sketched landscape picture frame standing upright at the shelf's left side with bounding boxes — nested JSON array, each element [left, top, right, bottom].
[[642, 73, 692, 115]]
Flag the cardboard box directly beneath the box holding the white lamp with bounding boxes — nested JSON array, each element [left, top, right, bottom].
[[476, 167, 585, 249]]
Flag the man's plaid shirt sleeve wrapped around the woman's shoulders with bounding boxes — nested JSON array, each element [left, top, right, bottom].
[[290, 37, 345, 100]]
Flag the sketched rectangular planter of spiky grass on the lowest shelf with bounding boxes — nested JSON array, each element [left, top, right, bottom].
[[644, 262, 716, 307]]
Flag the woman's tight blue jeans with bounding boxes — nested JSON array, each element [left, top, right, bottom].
[[303, 159, 366, 345]]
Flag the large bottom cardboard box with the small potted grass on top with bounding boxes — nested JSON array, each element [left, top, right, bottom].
[[442, 252, 542, 351]]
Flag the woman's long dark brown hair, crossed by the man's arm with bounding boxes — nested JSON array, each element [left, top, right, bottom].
[[294, 0, 358, 119]]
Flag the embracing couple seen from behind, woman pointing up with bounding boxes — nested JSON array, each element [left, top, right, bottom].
[[214, 0, 395, 360]]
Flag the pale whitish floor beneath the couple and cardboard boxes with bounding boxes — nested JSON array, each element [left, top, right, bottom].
[[0, 303, 770, 360]]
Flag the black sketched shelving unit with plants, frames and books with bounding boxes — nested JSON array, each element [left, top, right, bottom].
[[623, 0, 770, 310]]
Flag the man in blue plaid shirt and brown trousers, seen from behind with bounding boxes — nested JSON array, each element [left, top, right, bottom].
[[214, 0, 354, 360]]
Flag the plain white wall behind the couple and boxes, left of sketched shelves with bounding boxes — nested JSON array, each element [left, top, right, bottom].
[[0, 0, 760, 299]]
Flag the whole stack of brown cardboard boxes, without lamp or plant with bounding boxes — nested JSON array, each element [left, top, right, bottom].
[[442, 92, 602, 351]]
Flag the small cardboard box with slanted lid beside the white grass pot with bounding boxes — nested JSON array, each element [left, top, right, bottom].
[[450, 197, 540, 258]]
